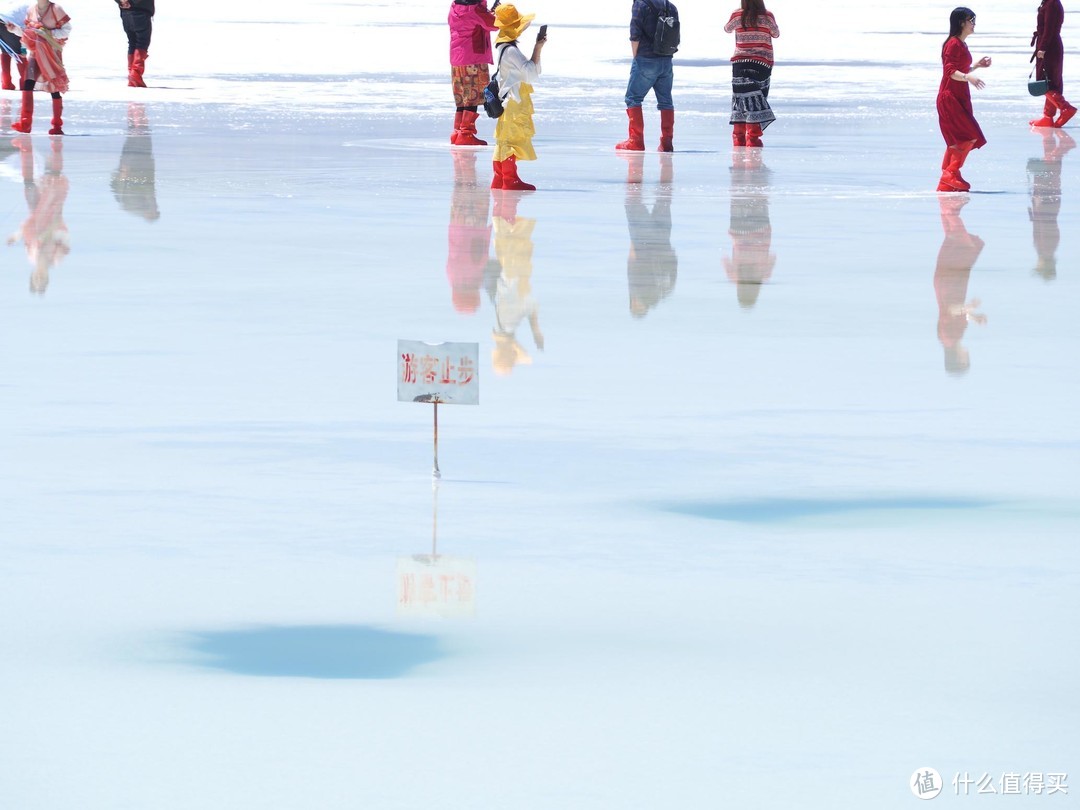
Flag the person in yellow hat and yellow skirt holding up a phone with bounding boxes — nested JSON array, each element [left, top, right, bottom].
[[491, 4, 548, 191]]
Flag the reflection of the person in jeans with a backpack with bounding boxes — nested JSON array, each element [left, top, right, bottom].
[[620, 152, 678, 318]]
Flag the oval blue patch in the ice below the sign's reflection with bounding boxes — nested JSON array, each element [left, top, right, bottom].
[[189, 624, 446, 680]]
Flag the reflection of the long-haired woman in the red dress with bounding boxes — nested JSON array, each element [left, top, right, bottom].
[[934, 194, 986, 375]]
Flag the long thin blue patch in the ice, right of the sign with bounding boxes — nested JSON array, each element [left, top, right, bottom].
[[661, 498, 997, 523]]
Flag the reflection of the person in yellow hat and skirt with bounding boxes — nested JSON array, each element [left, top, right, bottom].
[[488, 191, 543, 375]]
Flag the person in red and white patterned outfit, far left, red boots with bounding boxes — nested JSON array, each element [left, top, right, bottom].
[[8, 0, 71, 135]]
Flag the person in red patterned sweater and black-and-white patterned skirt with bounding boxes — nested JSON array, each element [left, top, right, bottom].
[[724, 0, 780, 146]]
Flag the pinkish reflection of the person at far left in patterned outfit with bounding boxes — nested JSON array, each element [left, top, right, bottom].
[[8, 135, 71, 295]]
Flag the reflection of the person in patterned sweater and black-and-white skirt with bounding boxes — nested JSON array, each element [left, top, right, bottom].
[[724, 149, 777, 310]]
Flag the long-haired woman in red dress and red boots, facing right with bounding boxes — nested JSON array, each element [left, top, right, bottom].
[[937, 6, 990, 191]]
